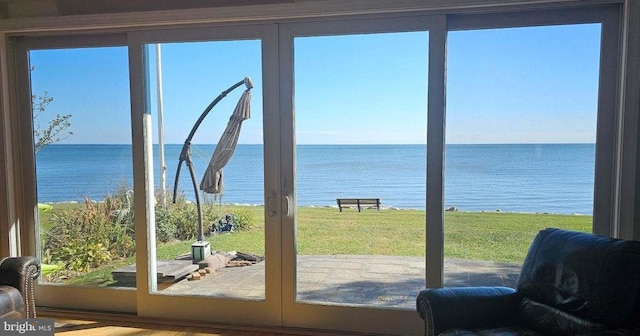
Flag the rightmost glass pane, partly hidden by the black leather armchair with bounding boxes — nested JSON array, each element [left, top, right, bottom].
[[444, 24, 600, 287]]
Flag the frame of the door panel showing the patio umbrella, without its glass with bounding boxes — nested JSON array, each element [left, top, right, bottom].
[[128, 24, 281, 325]]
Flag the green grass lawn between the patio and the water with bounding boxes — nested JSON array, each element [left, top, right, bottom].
[[41, 204, 592, 285]]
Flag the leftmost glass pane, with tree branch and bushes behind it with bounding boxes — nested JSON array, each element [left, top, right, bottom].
[[29, 47, 135, 286]]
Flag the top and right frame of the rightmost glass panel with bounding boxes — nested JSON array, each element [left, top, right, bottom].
[[447, 4, 624, 237]]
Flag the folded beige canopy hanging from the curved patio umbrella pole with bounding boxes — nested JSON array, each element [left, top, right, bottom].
[[200, 86, 251, 194]]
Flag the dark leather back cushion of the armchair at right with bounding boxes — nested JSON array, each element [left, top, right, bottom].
[[517, 229, 640, 327]]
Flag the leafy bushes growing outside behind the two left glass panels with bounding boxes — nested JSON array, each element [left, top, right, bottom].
[[42, 184, 254, 272]]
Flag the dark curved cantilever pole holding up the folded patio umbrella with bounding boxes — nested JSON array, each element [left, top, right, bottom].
[[173, 77, 253, 242]]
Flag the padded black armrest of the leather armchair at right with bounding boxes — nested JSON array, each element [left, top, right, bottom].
[[416, 287, 521, 335]]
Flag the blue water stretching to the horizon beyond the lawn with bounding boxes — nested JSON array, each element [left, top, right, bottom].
[[36, 144, 595, 214]]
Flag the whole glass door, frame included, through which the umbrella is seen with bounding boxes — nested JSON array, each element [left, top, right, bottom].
[[126, 26, 280, 325]]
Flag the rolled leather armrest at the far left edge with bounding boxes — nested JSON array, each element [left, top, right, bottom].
[[0, 256, 40, 318]]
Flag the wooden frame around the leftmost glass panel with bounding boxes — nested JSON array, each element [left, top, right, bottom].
[[13, 34, 136, 312]]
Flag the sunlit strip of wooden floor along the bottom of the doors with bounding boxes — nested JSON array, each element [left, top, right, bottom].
[[38, 311, 364, 336]]
